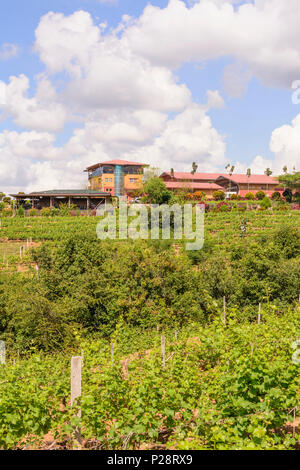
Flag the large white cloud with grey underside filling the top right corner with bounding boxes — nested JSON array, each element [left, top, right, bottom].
[[124, 0, 300, 87]]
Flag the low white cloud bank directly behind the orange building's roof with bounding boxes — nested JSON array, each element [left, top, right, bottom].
[[0, 104, 226, 191]]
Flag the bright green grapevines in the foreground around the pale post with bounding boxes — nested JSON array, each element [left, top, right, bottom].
[[0, 309, 300, 450]]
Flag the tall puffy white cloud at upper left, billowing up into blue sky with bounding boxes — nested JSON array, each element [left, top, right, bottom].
[[35, 11, 191, 112]]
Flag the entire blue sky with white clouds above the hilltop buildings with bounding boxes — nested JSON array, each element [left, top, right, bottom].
[[0, 0, 300, 193]]
